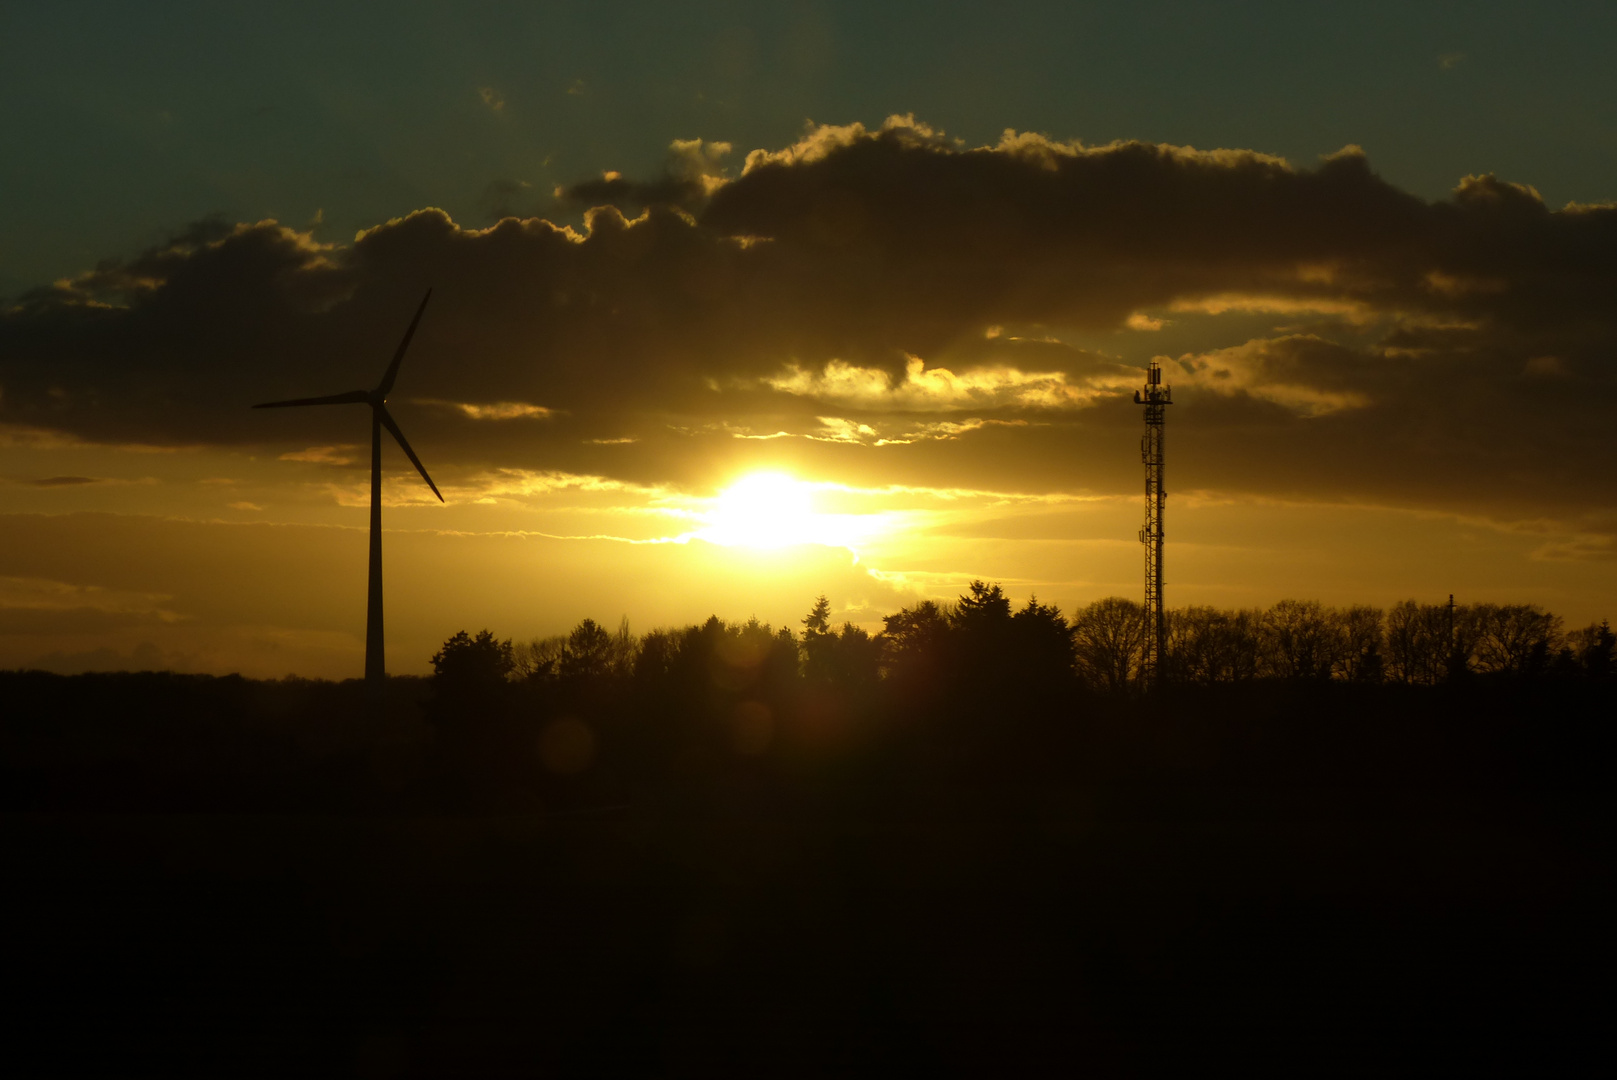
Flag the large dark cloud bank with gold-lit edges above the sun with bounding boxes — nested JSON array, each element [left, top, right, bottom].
[[0, 120, 1617, 534]]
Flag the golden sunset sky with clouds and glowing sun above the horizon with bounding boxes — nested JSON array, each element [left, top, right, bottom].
[[0, 3, 1617, 677]]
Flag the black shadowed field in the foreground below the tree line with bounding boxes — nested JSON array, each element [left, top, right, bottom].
[[0, 673, 1617, 1077]]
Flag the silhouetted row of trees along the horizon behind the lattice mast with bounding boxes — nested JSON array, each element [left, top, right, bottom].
[[432, 580, 1617, 692]]
